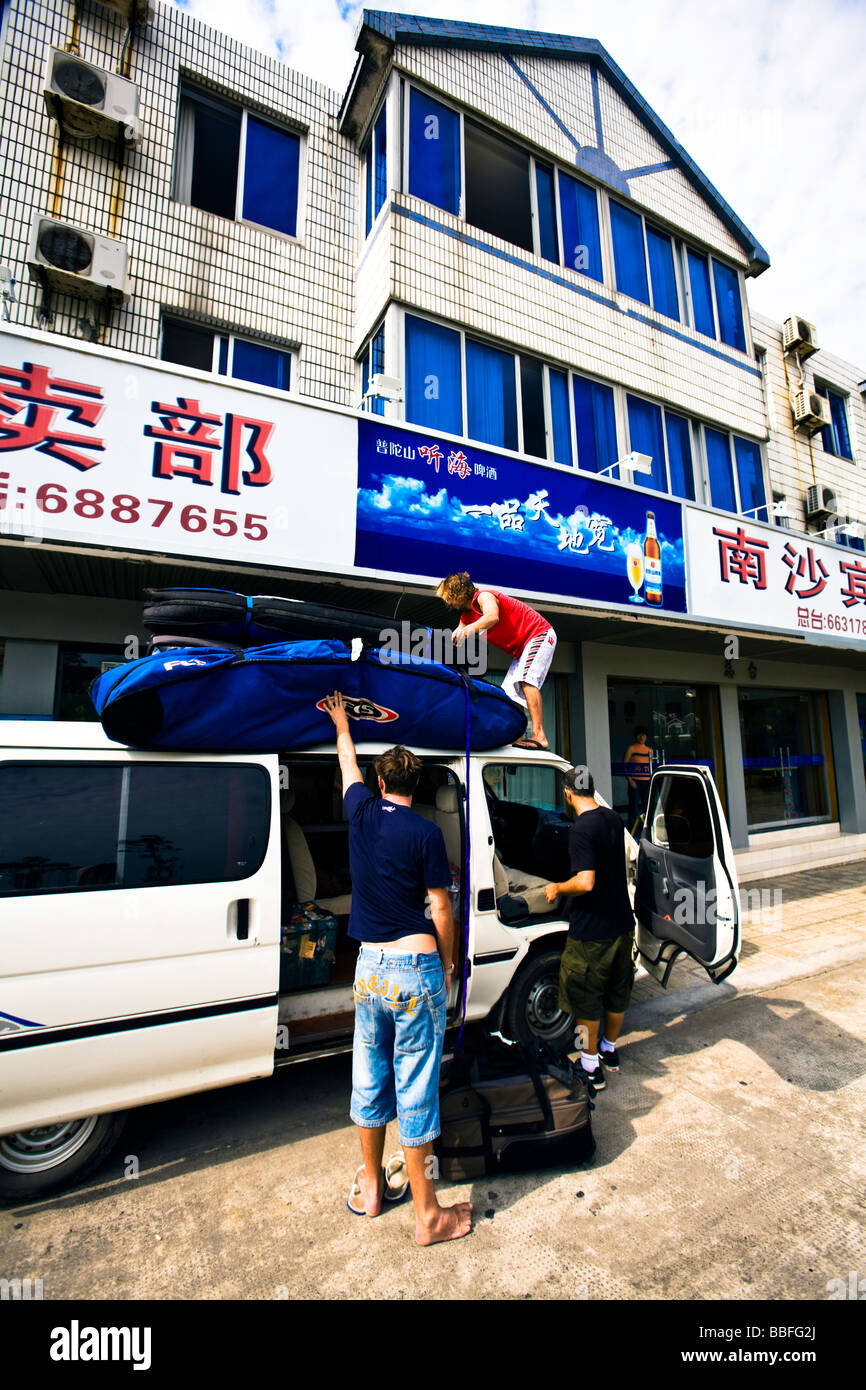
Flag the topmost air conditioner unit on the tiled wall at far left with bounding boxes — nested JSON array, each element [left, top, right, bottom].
[[42, 49, 140, 143]]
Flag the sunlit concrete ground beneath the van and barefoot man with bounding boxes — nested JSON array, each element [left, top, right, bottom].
[[0, 960, 866, 1295]]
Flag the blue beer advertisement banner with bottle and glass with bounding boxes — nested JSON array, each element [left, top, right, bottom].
[[354, 420, 687, 613]]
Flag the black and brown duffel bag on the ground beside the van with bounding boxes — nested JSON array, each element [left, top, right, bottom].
[[434, 1038, 595, 1183]]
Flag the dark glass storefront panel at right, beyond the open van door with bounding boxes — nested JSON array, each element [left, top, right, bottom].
[[740, 689, 830, 830]]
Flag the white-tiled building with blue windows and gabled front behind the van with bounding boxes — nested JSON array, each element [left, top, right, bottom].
[[0, 0, 866, 863]]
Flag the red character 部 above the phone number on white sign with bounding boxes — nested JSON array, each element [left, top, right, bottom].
[[145, 396, 274, 496]]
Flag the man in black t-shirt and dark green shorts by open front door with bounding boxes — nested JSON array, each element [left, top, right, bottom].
[[545, 767, 634, 1091]]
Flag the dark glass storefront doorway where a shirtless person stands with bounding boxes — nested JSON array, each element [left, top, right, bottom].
[[607, 680, 724, 828]]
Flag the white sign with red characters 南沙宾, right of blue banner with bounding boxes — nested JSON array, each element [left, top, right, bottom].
[[685, 507, 866, 644]]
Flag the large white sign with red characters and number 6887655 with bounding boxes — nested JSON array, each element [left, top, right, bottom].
[[0, 331, 356, 569]]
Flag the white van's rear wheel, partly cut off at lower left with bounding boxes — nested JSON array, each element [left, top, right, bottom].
[[0, 1111, 126, 1202]]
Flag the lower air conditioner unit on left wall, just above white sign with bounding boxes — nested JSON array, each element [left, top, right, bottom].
[[26, 213, 129, 304]]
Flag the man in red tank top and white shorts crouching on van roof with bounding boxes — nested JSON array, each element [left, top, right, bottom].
[[436, 571, 556, 748]]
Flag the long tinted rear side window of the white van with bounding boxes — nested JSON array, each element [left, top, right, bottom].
[[0, 762, 271, 897]]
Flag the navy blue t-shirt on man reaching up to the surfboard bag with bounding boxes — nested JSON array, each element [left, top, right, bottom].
[[343, 783, 452, 941]]
